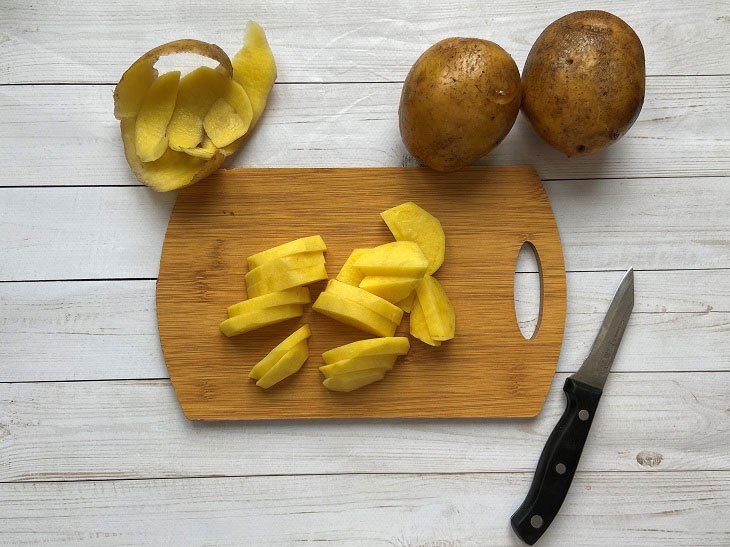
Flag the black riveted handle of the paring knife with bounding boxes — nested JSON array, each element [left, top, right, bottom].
[[510, 378, 602, 545]]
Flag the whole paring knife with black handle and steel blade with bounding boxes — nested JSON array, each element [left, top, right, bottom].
[[510, 268, 634, 545]]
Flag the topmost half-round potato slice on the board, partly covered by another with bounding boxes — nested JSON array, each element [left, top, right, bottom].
[[380, 201, 446, 275]]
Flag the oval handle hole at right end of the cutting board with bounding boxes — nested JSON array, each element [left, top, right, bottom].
[[513, 241, 543, 340]]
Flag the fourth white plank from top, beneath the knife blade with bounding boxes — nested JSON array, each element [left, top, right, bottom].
[[0, 268, 730, 382]]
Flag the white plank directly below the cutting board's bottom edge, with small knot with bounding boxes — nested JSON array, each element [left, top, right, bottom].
[[0, 372, 730, 482]]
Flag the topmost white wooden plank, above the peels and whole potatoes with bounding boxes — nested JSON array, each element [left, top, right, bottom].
[[0, 0, 730, 83]]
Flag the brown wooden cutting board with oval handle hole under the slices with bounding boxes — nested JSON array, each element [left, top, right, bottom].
[[157, 166, 565, 420]]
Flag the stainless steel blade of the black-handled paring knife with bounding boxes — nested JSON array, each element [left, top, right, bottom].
[[571, 268, 634, 389]]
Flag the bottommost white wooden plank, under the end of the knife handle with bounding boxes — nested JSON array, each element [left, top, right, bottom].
[[0, 471, 730, 547]]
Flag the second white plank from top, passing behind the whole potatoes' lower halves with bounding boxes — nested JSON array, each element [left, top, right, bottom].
[[0, 75, 730, 186]]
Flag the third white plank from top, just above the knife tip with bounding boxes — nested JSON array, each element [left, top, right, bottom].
[[0, 178, 730, 281]]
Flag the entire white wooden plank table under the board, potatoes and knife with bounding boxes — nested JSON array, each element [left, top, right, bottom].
[[0, 0, 730, 547]]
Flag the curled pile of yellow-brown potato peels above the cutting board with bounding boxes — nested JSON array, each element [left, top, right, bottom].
[[114, 22, 276, 192]]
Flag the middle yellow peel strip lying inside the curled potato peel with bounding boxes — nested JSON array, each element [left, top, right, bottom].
[[167, 66, 230, 151]]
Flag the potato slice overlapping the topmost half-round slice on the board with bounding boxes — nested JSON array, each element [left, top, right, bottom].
[[355, 241, 428, 278]]
